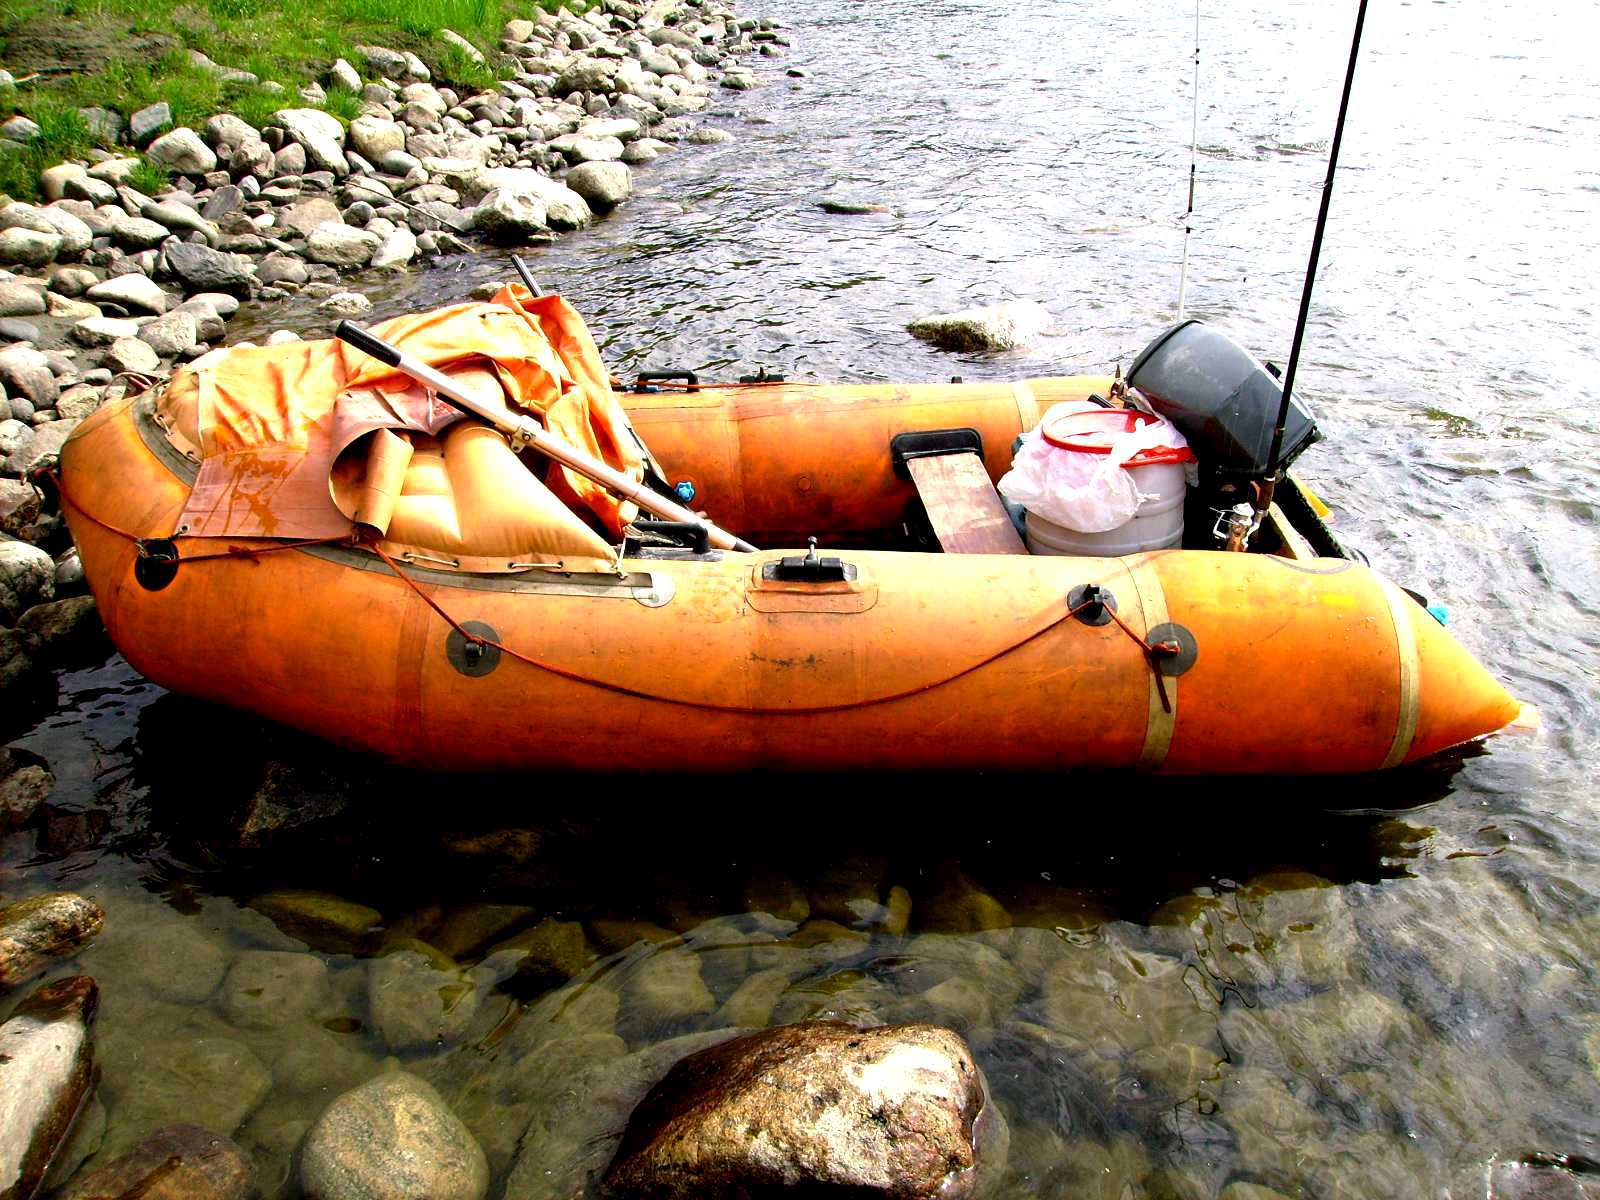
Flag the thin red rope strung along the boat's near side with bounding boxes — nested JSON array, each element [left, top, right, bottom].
[[46, 470, 1179, 717]]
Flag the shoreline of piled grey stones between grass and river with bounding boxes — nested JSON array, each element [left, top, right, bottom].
[[0, 0, 789, 720]]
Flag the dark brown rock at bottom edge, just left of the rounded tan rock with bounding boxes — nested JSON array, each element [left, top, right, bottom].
[[61, 1125, 256, 1200]]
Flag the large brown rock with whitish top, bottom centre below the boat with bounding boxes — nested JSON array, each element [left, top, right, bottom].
[[605, 1021, 984, 1200]]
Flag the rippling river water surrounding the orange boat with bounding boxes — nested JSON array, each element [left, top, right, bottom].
[[12, 0, 1600, 1197]]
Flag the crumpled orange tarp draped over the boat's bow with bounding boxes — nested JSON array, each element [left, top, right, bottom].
[[172, 283, 643, 538]]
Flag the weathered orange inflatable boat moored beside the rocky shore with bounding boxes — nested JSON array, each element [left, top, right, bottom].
[[59, 288, 1518, 773]]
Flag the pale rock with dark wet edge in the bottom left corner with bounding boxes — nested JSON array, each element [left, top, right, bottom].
[[0, 974, 99, 1200]]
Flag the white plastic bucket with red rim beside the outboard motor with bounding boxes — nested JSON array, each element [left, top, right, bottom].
[[1027, 406, 1195, 557]]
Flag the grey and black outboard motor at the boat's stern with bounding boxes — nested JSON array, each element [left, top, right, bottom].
[[1128, 320, 1322, 547]]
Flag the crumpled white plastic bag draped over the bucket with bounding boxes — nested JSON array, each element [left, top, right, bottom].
[[997, 400, 1187, 533]]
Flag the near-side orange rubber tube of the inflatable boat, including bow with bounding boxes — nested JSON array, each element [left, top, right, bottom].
[[61, 397, 1518, 774]]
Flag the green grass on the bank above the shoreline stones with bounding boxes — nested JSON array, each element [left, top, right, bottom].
[[0, 0, 587, 198]]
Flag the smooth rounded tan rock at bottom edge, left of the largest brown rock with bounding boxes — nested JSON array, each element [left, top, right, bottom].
[[301, 1070, 490, 1200]]
